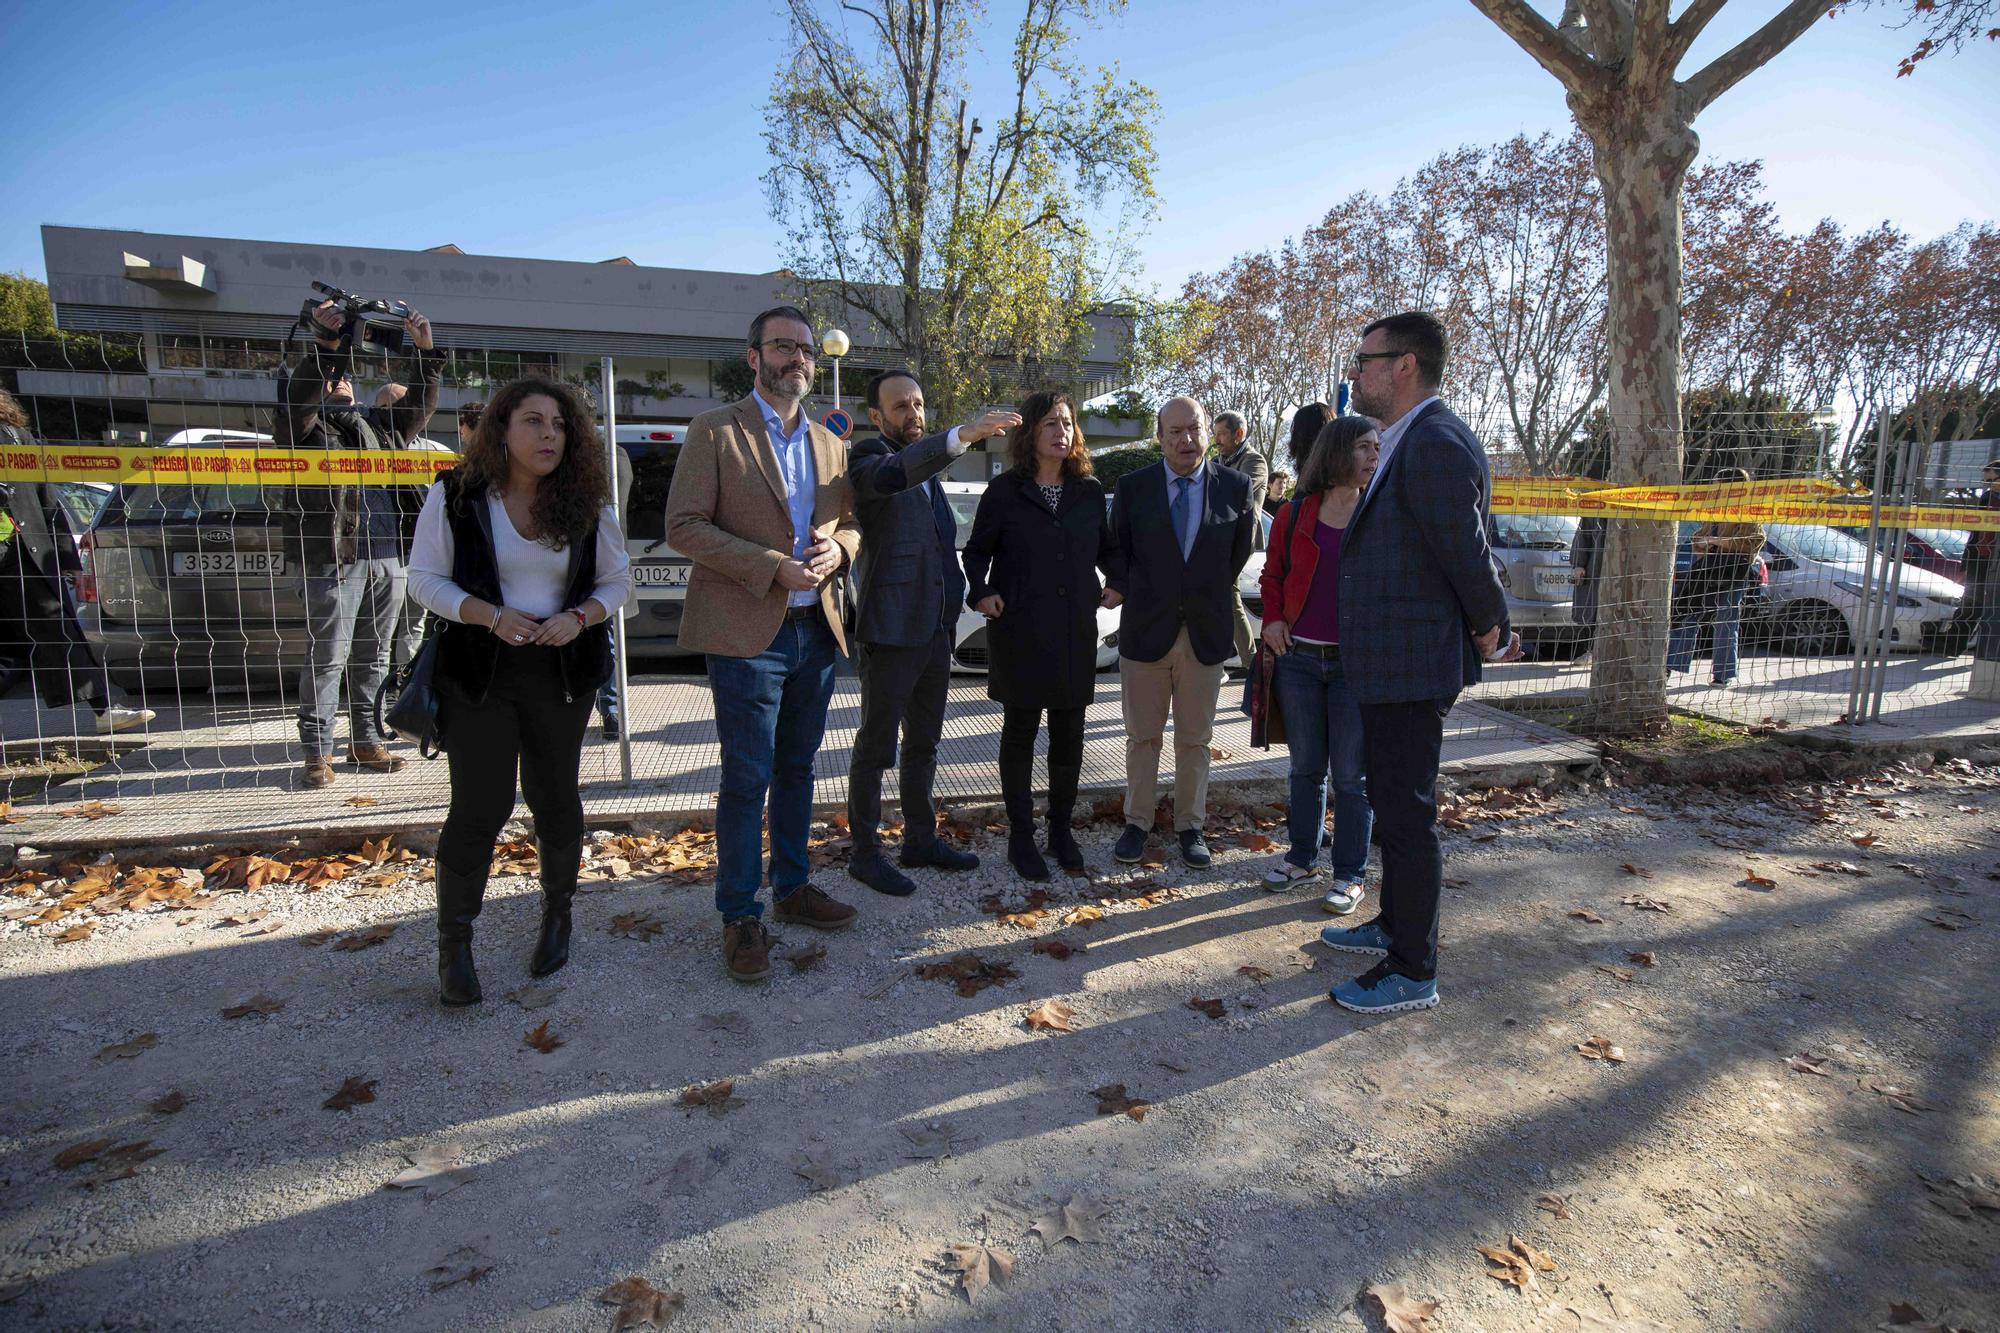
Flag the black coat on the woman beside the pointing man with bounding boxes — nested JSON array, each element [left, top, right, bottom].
[[966, 472, 1124, 709]]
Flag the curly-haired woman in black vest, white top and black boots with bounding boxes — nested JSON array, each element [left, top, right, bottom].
[[410, 380, 632, 1005]]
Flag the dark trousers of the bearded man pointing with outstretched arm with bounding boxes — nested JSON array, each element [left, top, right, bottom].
[[848, 628, 952, 849]]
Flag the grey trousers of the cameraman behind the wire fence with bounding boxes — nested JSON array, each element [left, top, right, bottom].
[[298, 560, 406, 752]]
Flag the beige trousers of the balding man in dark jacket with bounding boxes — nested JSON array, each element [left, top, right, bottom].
[[1118, 628, 1224, 833]]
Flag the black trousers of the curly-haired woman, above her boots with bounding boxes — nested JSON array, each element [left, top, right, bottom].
[[438, 646, 596, 875]]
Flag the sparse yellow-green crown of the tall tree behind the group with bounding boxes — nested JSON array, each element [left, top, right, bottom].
[[764, 0, 1158, 416]]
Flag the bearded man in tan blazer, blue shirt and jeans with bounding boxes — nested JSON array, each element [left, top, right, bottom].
[[666, 306, 860, 981]]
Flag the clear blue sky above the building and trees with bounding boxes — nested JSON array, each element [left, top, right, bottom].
[[0, 0, 2000, 290]]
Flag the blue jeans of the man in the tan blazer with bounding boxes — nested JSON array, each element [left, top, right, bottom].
[[708, 616, 834, 923]]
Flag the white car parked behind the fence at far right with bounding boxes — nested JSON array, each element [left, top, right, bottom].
[[1746, 522, 1964, 656]]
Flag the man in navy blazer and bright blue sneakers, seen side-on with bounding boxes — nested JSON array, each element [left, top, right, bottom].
[[1320, 312, 1520, 1013]]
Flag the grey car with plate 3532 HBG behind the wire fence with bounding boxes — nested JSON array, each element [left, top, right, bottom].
[[76, 430, 306, 689]]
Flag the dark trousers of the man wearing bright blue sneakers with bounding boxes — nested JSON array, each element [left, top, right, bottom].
[[1362, 695, 1456, 981]]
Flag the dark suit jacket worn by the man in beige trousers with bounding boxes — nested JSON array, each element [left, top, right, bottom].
[[1112, 460, 1262, 667]]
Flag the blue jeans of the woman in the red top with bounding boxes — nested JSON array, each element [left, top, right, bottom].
[[1272, 652, 1374, 879]]
